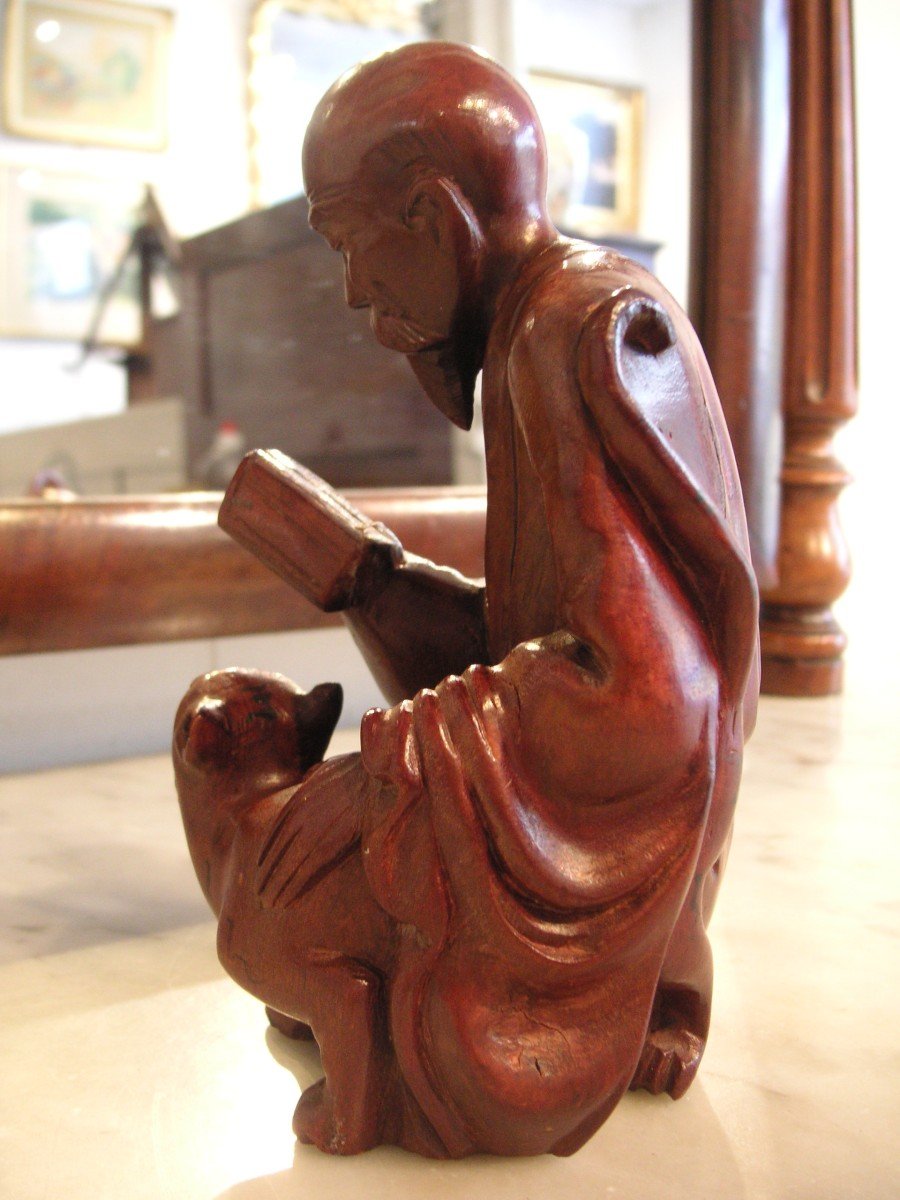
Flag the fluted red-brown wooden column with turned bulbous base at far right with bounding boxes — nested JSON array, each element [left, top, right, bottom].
[[761, 0, 857, 695]]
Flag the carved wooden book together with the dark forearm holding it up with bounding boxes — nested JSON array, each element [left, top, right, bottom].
[[218, 450, 486, 703]]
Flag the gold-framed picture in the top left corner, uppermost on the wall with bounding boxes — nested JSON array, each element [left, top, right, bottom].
[[4, 0, 172, 150]]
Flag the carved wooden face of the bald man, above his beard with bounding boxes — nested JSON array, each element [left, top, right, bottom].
[[310, 188, 460, 355]]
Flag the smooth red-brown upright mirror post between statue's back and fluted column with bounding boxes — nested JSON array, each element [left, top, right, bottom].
[[688, 0, 790, 587]]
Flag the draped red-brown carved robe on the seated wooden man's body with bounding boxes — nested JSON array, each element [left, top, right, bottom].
[[214, 242, 756, 1156]]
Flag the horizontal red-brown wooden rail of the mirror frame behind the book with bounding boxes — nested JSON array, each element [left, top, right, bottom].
[[0, 487, 485, 654]]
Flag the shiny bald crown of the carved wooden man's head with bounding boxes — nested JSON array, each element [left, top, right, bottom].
[[304, 42, 546, 228]]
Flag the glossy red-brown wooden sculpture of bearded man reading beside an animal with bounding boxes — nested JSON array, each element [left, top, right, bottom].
[[174, 43, 758, 1157]]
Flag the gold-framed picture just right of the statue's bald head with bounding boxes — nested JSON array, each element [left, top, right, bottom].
[[526, 71, 643, 238]]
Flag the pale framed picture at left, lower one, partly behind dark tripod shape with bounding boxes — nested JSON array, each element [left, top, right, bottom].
[[0, 166, 144, 346]]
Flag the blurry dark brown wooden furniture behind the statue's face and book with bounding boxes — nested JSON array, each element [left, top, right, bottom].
[[127, 197, 452, 487]]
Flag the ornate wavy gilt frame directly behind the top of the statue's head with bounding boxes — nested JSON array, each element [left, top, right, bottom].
[[248, 0, 427, 206]]
